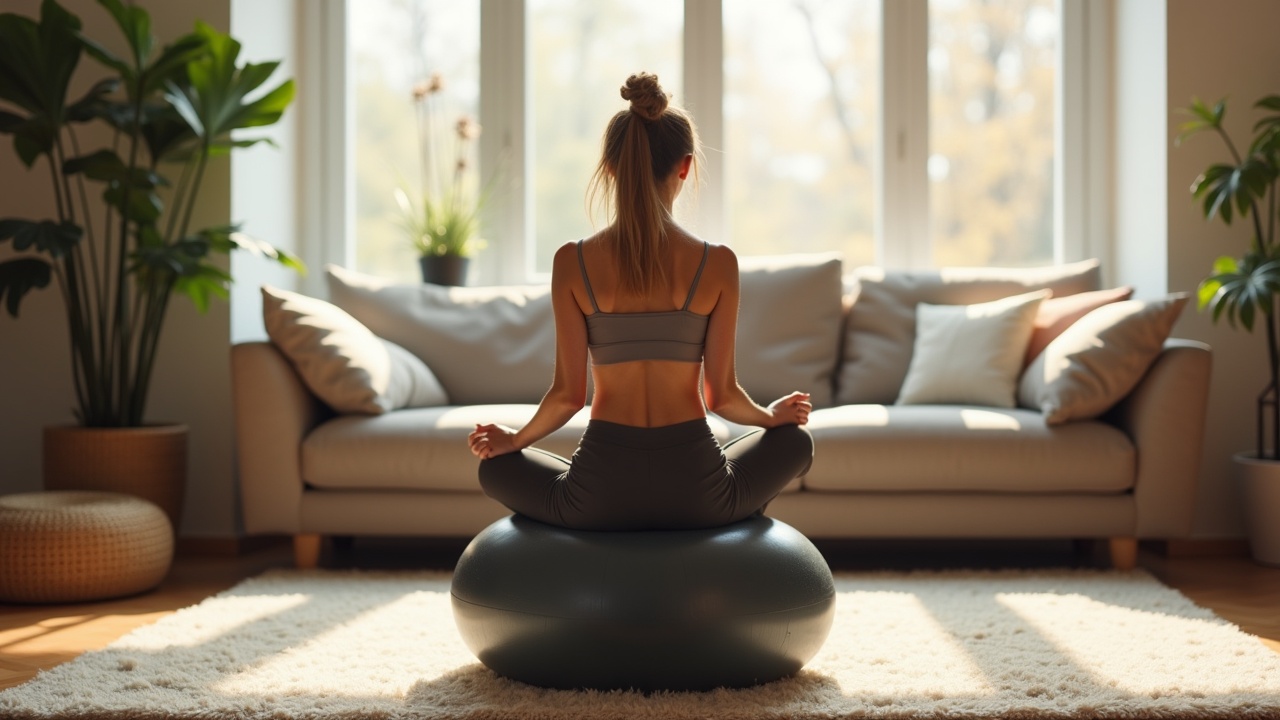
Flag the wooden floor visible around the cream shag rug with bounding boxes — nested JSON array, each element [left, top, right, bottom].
[[0, 538, 1280, 689]]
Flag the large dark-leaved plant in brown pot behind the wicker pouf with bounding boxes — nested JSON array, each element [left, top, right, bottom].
[[0, 0, 301, 528]]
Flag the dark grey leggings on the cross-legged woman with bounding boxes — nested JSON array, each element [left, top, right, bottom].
[[480, 419, 813, 530]]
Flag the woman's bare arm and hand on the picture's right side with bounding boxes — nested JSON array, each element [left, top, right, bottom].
[[703, 246, 813, 428]]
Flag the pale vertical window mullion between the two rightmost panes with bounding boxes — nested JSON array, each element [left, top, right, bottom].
[[876, 0, 933, 268]]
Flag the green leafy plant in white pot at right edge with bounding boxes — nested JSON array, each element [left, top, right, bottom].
[[1178, 95, 1280, 565]]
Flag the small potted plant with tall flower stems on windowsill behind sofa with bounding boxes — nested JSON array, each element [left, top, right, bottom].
[[396, 74, 488, 286]]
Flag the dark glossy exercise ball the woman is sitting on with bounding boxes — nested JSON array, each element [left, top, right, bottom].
[[452, 515, 836, 692]]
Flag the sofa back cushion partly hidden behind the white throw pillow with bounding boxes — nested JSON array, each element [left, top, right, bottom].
[[839, 260, 1101, 405]]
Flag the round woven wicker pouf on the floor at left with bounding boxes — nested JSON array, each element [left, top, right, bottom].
[[0, 492, 173, 602]]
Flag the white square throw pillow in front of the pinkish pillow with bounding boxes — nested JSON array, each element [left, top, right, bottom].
[[897, 290, 1051, 407]]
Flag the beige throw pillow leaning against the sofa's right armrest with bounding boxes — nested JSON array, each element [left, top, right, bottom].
[[1018, 293, 1187, 425]]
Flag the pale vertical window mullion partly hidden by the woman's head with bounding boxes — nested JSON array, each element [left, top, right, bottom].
[[684, 0, 728, 243]]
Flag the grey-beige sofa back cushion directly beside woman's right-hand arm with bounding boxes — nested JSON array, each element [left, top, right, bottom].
[[736, 254, 842, 407]]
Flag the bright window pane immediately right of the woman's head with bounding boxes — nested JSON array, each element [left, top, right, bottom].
[[723, 0, 881, 264]]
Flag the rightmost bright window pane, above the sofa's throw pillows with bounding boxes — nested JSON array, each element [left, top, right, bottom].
[[928, 0, 1059, 265]]
